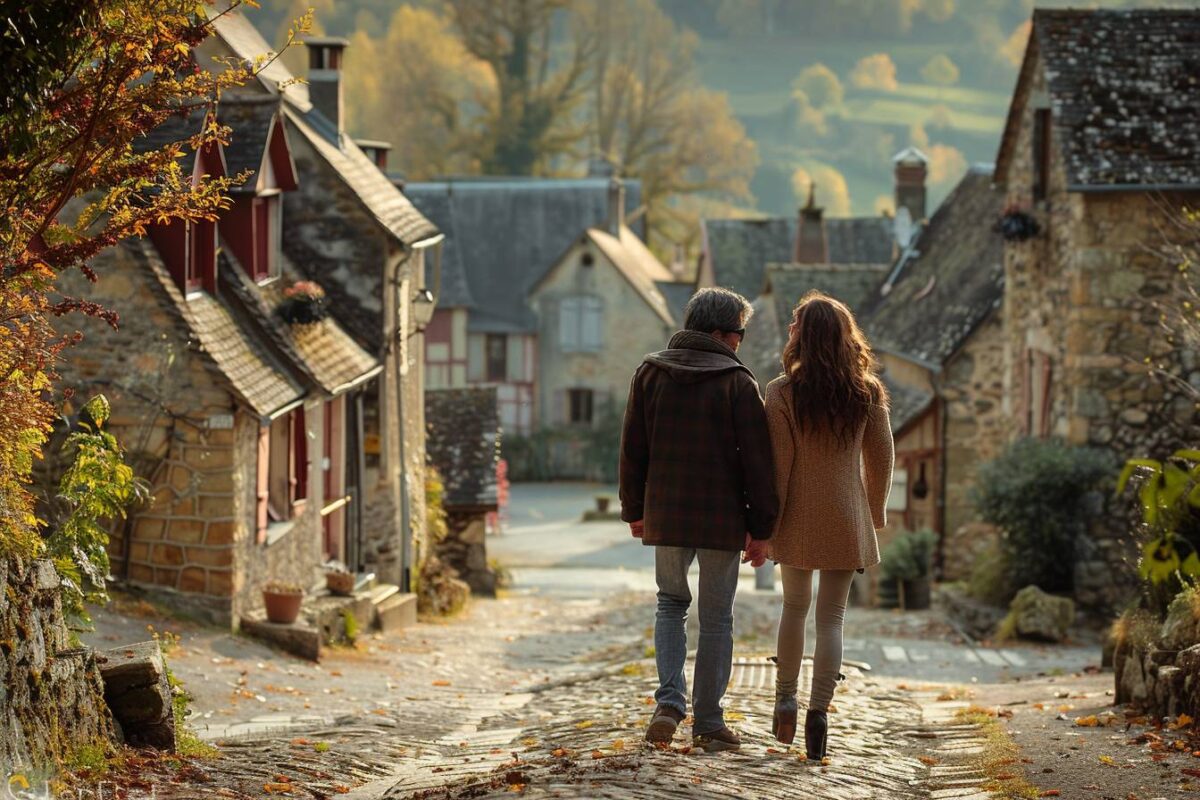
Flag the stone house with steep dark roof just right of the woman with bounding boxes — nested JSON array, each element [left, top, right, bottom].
[[860, 166, 1008, 579]]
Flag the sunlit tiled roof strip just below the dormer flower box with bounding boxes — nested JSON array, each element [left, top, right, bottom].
[[220, 248, 379, 395]]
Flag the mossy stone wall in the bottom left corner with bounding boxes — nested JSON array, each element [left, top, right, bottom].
[[0, 560, 116, 783]]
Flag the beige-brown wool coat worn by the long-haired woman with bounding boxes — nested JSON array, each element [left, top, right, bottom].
[[767, 375, 895, 570]]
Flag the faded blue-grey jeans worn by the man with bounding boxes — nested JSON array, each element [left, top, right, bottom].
[[654, 547, 742, 735]]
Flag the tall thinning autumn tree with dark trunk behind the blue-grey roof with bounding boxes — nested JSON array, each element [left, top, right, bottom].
[[449, 0, 594, 175]]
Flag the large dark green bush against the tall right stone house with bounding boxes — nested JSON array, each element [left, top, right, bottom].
[[973, 439, 1116, 591]]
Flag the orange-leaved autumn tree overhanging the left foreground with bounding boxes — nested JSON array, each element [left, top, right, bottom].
[[0, 0, 300, 563]]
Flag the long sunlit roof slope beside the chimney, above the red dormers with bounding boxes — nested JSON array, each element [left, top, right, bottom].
[[214, 12, 438, 245]]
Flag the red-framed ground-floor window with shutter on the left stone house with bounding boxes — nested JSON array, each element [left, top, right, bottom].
[[258, 407, 308, 536]]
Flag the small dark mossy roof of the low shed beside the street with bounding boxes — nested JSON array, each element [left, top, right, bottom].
[[425, 387, 500, 510]]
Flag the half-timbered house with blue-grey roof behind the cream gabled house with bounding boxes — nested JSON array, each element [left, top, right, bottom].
[[400, 176, 641, 437]]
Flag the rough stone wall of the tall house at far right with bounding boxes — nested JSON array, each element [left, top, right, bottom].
[[997, 48, 1200, 610]]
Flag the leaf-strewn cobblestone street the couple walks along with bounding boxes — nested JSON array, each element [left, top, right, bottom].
[[77, 488, 1098, 800]]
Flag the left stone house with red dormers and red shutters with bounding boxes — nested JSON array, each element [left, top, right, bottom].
[[61, 97, 382, 624]]
